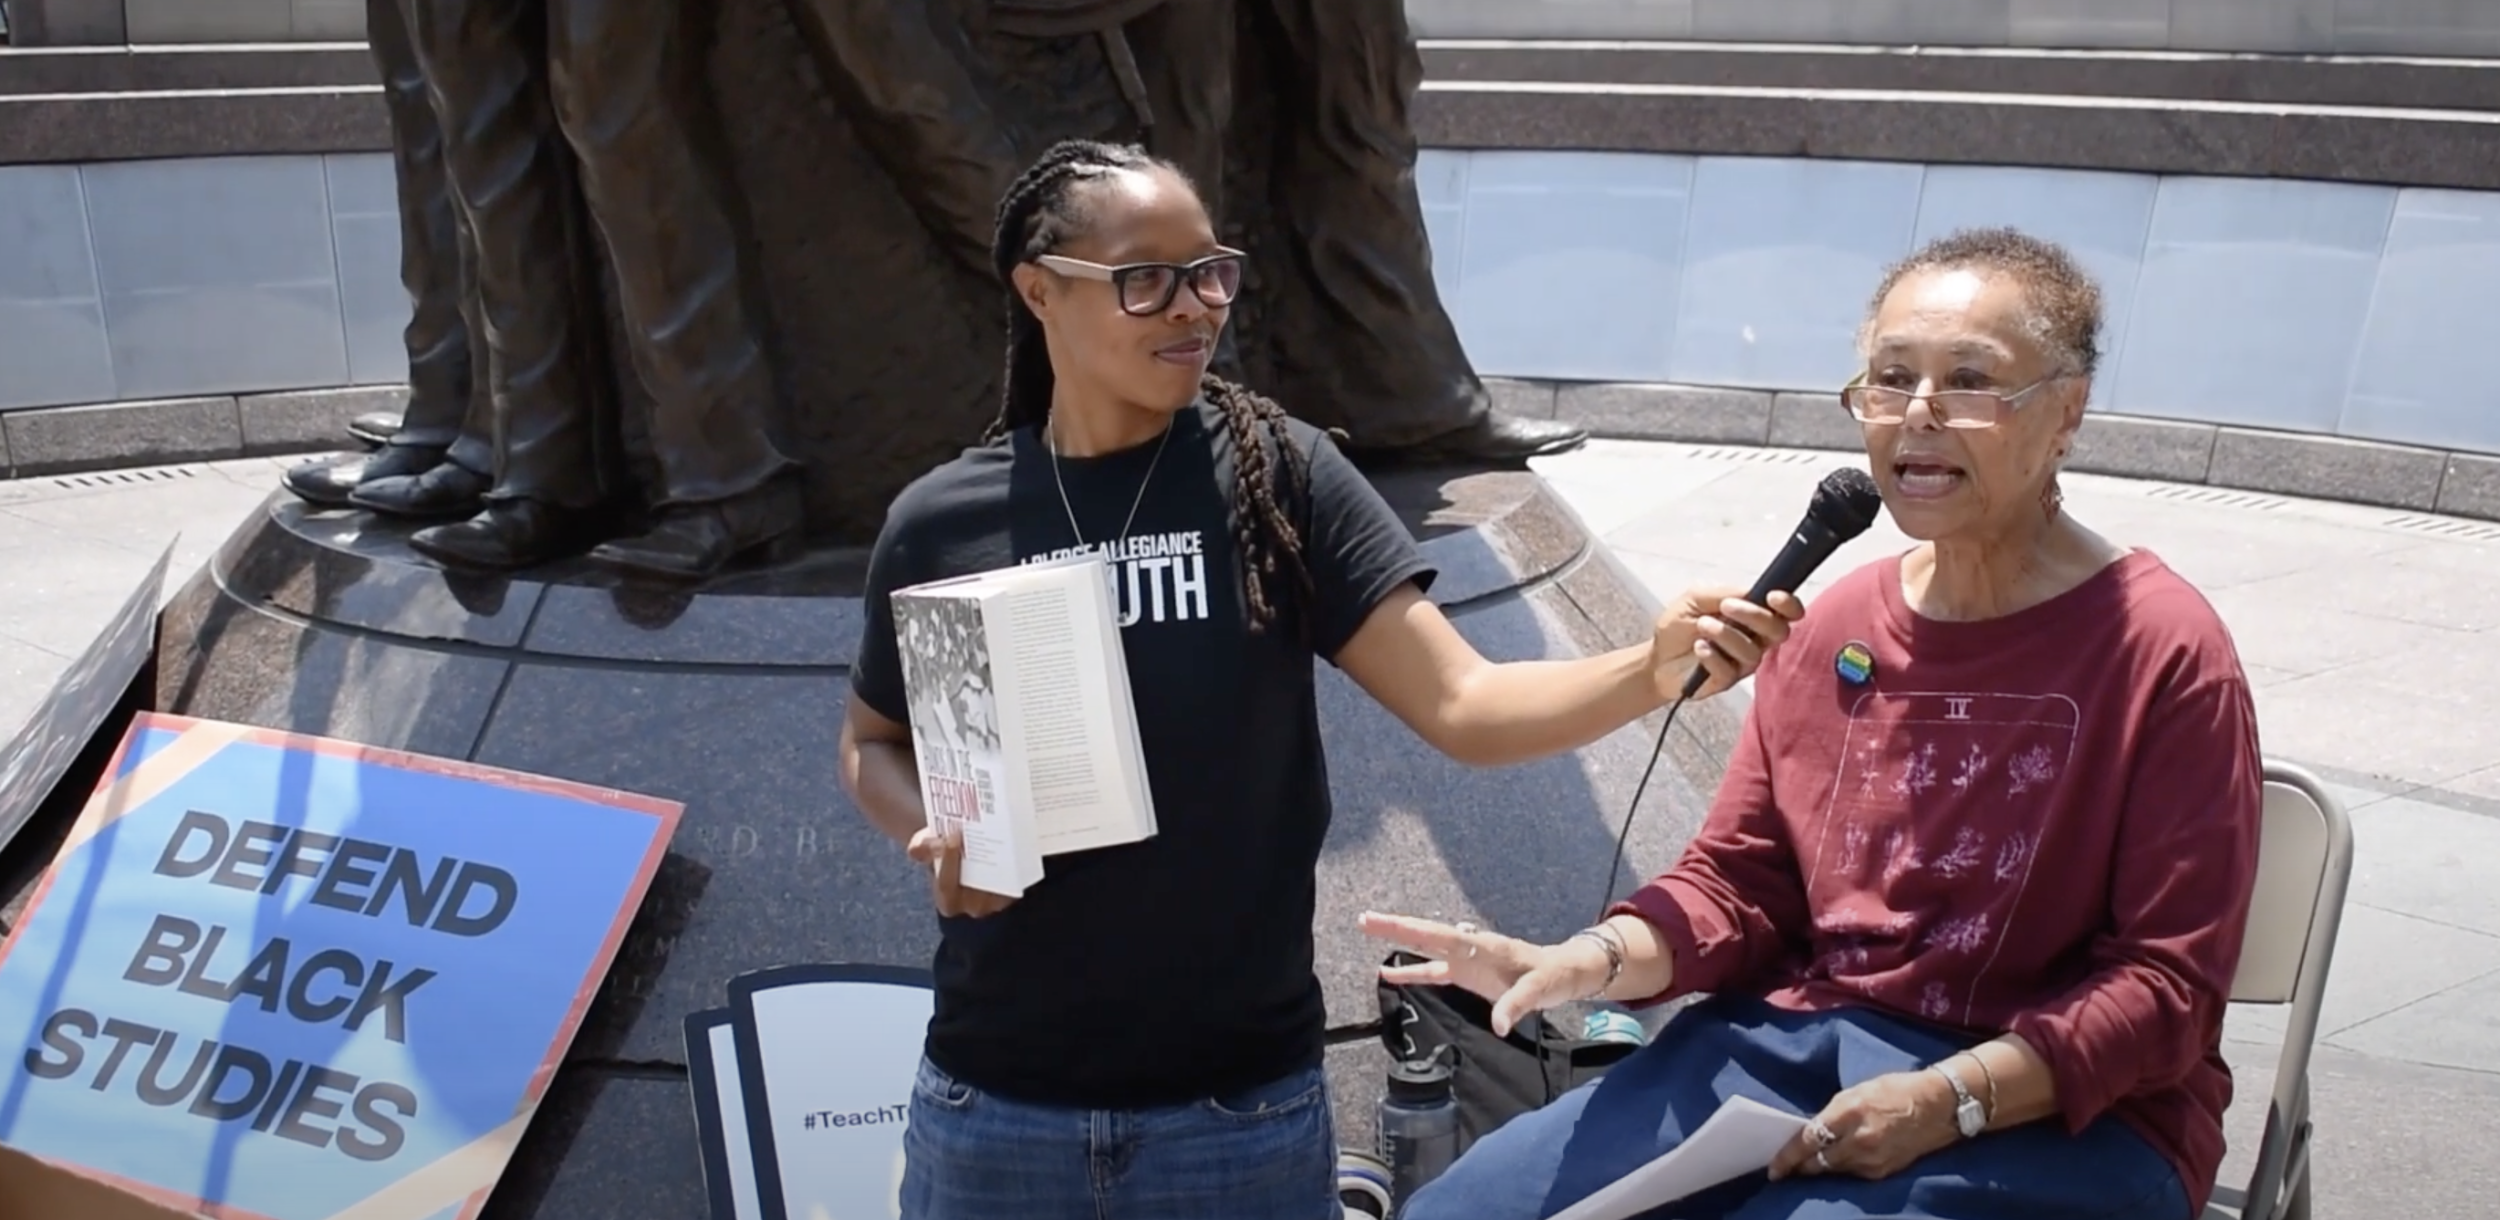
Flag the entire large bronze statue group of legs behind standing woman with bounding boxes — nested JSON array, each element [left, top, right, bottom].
[[288, 0, 1585, 578]]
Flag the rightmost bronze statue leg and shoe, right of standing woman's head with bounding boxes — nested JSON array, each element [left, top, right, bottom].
[[1250, 0, 1588, 460]]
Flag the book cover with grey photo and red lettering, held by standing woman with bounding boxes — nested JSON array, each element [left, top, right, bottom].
[[895, 593, 1043, 898]]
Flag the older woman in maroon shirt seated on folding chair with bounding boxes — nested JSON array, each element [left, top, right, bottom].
[[1365, 230, 2260, 1220]]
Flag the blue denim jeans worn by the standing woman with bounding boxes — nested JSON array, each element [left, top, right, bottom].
[[903, 1060, 1340, 1220]]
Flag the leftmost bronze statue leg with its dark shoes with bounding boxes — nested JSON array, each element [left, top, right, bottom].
[[283, 0, 495, 518]]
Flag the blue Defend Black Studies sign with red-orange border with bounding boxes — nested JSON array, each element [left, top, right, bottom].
[[0, 715, 680, 1220]]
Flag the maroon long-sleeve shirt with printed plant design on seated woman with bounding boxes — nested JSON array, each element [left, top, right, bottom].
[[1618, 550, 2263, 1213]]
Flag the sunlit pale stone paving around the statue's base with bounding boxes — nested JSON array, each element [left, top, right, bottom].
[[0, 440, 2500, 1220]]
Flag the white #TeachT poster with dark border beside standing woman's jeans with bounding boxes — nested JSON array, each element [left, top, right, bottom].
[[730, 965, 933, 1220]]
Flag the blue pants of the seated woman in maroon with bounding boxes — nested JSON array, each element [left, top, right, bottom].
[[1398, 995, 2193, 1220]]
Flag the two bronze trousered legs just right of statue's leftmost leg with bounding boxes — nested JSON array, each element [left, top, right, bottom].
[[410, 0, 800, 578]]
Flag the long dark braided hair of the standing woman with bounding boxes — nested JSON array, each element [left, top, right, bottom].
[[983, 140, 1313, 633]]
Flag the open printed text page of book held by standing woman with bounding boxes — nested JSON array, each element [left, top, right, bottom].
[[995, 558, 1155, 855]]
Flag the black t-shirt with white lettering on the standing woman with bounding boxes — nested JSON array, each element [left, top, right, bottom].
[[853, 403, 1435, 1108]]
